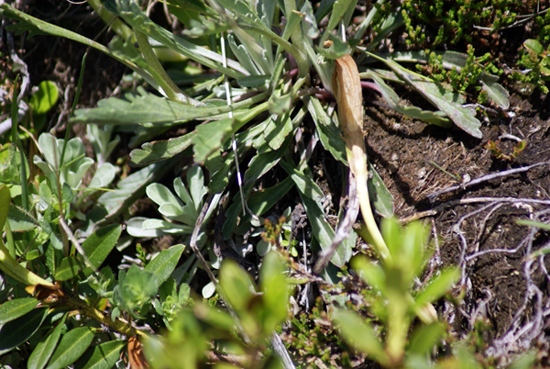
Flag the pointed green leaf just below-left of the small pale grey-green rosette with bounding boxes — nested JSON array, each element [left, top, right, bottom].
[[82, 224, 122, 277]]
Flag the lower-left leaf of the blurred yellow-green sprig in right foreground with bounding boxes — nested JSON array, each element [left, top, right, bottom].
[[334, 309, 389, 366]]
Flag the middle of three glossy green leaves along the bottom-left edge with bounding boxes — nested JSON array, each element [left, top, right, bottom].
[[46, 327, 94, 369]]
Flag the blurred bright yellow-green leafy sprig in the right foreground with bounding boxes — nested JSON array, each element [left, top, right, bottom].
[[340, 220, 459, 367]]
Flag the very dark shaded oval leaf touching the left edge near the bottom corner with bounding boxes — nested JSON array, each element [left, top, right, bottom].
[[0, 308, 48, 355]]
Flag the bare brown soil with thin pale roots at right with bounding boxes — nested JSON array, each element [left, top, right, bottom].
[[366, 87, 550, 364]]
